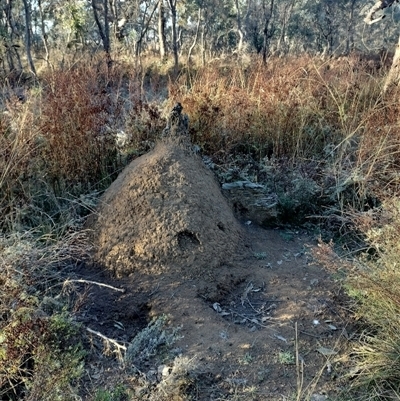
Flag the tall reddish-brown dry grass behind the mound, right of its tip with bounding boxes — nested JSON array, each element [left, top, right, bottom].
[[166, 56, 379, 160]]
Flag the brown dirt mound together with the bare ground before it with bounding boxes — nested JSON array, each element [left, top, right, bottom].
[[78, 136, 350, 401]]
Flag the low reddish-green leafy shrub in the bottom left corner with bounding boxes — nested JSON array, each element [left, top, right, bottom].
[[0, 308, 85, 401]]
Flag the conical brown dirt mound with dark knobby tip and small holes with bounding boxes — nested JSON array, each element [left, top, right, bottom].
[[91, 104, 241, 276]]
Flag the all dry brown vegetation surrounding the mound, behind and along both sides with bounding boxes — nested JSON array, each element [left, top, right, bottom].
[[0, 56, 400, 400]]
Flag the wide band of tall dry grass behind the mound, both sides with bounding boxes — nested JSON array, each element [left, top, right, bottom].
[[0, 56, 388, 230]]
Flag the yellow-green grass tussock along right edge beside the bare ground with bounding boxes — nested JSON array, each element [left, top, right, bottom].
[[317, 199, 400, 401]]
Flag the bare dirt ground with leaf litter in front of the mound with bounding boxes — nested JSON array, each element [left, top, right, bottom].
[[79, 225, 350, 400]]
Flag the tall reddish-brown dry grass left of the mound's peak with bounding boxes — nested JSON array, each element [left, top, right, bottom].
[[0, 63, 166, 232]]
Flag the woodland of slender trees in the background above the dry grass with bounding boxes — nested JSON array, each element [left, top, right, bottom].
[[0, 0, 400, 74]]
